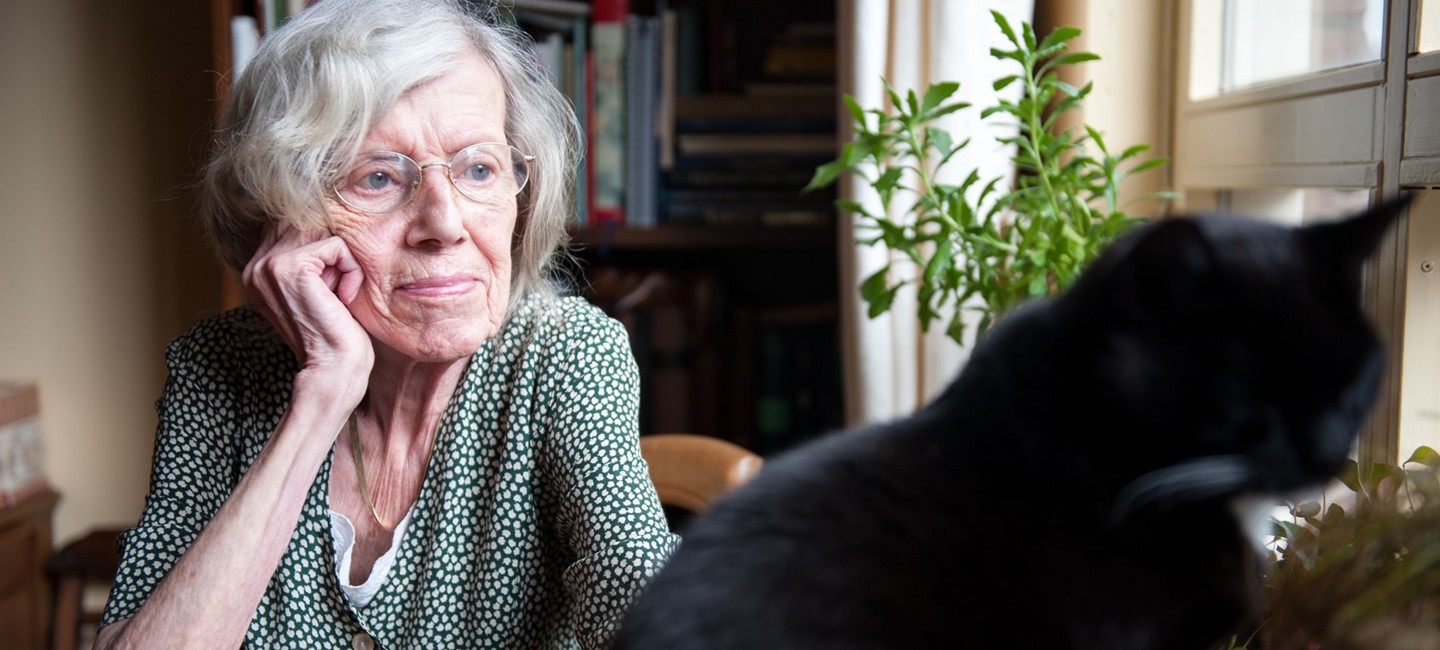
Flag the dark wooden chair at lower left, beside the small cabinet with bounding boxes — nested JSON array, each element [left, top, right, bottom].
[[45, 529, 121, 650]]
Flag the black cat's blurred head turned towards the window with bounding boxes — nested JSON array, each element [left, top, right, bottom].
[[1061, 200, 1405, 509]]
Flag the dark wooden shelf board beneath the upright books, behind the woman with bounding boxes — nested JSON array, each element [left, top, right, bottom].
[[570, 225, 835, 251]]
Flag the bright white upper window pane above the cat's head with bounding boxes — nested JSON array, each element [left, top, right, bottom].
[[1191, 0, 1385, 98]]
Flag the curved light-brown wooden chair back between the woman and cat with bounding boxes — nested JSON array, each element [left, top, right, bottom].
[[639, 434, 765, 529]]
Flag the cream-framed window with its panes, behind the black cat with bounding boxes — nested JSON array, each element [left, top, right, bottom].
[[1172, 0, 1440, 463]]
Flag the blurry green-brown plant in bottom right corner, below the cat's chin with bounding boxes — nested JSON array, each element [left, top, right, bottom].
[[1224, 447, 1440, 650]]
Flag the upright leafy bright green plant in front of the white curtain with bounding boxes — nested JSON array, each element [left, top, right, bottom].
[[806, 12, 1165, 343]]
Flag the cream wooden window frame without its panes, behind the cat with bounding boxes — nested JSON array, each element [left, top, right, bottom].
[[1171, 0, 1440, 467]]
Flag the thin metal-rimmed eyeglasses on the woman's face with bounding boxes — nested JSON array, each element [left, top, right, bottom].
[[334, 143, 534, 215]]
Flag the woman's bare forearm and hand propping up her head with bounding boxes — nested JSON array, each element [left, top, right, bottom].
[[95, 231, 374, 649]]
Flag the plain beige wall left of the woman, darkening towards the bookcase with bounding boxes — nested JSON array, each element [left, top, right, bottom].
[[0, 0, 217, 542]]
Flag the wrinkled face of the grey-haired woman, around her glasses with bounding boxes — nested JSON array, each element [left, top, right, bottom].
[[328, 49, 516, 362]]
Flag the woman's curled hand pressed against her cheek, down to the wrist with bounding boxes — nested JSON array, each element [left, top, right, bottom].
[[243, 226, 374, 404]]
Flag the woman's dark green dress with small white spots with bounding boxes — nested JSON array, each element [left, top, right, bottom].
[[104, 298, 677, 649]]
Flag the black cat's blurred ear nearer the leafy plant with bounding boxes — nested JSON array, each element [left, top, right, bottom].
[[1117, 218, 1215, 316]]
